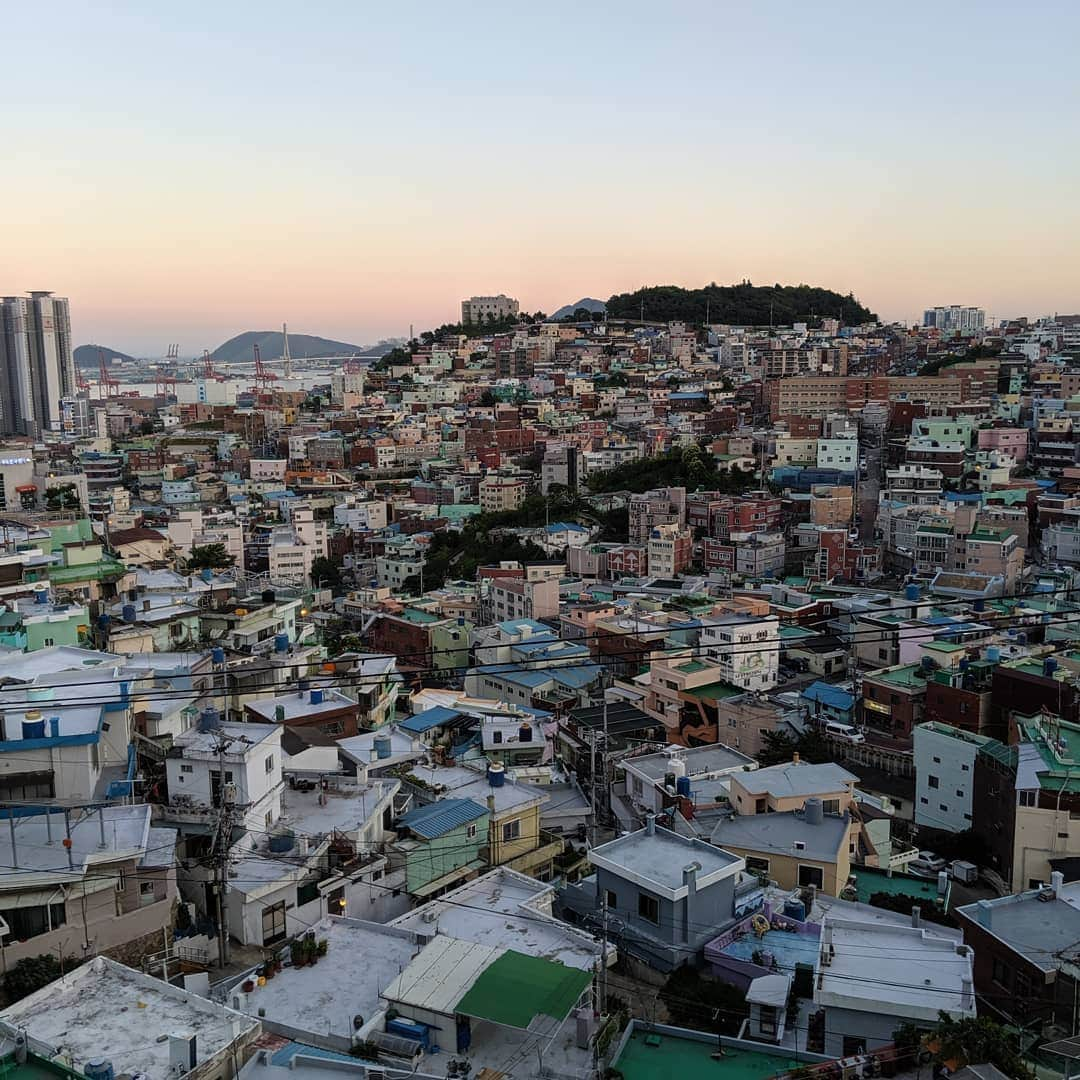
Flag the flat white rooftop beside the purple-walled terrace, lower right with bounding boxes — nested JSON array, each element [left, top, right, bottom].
[[813, 916, 975, 1022]]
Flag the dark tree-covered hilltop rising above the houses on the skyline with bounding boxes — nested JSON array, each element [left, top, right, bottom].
[[607, 281, 877, 326]]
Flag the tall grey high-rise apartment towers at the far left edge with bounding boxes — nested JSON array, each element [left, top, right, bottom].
[[0, 292, 76, 436]]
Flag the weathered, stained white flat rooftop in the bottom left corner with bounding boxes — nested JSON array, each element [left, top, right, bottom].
[[0, 957, 258, 1080]]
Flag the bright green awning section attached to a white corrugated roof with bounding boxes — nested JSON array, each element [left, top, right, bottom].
[[457, 949, 593, 1030]]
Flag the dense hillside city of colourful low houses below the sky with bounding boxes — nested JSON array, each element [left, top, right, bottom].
[[0, 283, 1080, 1080]]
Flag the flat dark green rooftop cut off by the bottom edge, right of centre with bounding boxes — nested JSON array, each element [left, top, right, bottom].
[[613, 1030, 806, 1080]]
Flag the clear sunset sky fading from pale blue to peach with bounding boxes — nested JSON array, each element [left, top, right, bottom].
[[0, 0, 1080, 356]]
